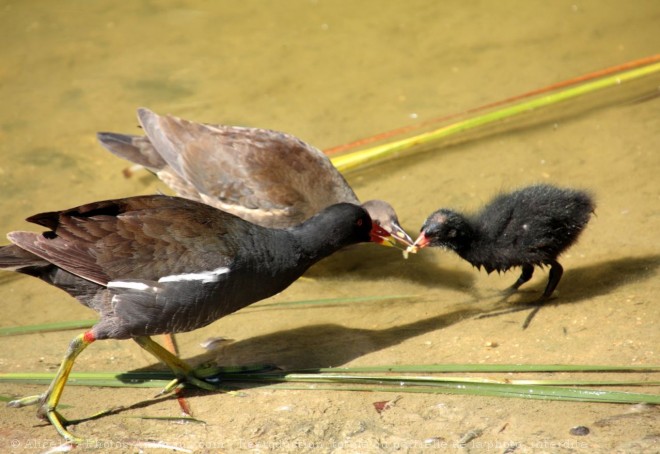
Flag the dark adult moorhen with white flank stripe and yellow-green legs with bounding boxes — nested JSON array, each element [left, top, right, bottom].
[[0, 196, 391, 443]]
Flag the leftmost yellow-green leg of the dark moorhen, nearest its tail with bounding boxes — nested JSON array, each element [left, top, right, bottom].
[[9, 331, 96, 443]]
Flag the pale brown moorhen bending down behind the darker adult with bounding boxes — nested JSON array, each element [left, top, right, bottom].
[[98, 108, 412, 246]]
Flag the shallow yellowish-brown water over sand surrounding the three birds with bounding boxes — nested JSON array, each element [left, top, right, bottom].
[[0, 0, 660, 452]]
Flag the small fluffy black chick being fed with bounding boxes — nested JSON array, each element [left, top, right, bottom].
[[409, 184, 595, 328]]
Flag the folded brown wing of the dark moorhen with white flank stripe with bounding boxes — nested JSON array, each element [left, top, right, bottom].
[[8, 196, 242, 285]]
